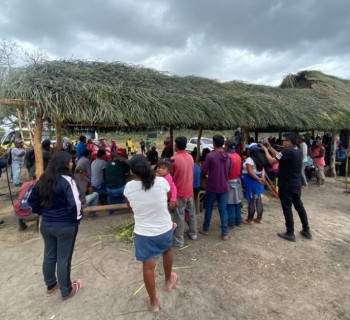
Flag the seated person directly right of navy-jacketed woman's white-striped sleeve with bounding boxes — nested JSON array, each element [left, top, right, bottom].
[[74, 167, 98, 218]]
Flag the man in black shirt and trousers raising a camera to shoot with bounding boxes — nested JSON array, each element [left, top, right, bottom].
[[261, 132, 312, 242]]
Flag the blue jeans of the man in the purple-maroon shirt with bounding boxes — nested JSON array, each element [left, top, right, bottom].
[[203, 191, 228, 236]]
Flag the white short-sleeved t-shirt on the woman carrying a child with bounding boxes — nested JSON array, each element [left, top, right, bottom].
[[124, 177, 173, 236]]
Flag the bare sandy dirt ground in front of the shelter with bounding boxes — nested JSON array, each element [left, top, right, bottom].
[[0, 169, 350, 320]]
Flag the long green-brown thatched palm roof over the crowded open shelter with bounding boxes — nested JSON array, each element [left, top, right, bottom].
[[0, 61, 350, 130]]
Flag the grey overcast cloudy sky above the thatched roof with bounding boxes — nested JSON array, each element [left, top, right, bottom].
[[0, 0, 350, 85]]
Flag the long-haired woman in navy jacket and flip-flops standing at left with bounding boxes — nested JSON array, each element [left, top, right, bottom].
[[28, 151, 83, 300]]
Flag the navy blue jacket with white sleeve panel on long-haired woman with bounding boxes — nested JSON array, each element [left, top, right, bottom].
[[28, 175, 83, 227]]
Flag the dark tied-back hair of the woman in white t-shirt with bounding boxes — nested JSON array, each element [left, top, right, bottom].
[[129, 154, 156, 191]]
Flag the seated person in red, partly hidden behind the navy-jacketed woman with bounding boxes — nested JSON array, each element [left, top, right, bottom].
[[13, 179, 38, 231]]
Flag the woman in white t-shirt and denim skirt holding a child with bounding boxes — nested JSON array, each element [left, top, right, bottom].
[[124, 155, 177, 312]]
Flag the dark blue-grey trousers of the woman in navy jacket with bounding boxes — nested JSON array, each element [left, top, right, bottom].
[[40, 226, 78, 297]]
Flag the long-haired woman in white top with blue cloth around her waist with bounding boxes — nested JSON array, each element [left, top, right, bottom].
[[243, 143, 266, 224]]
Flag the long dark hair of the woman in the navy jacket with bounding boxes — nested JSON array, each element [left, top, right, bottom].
[[35, 151, 73, 207]]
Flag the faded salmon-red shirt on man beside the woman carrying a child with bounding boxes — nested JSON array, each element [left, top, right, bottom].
[[171, 150, 193, 199]]
